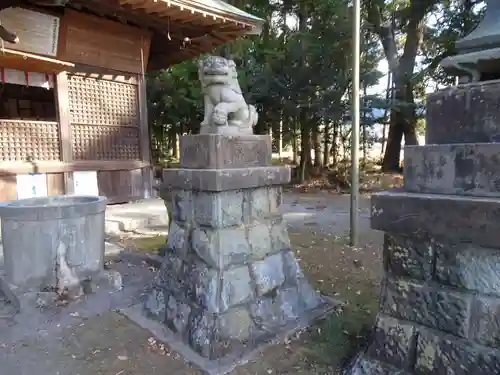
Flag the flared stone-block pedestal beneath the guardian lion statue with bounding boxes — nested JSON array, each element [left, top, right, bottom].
[[140, 134, 329, 373]]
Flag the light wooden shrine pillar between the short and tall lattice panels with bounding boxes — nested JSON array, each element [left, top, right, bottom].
[[55, 72, 74, 194]]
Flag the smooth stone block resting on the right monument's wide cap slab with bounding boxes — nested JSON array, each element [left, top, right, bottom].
[[404, 143, 500, 197]]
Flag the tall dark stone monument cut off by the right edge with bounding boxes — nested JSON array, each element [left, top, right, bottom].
[[346, 0, 500, 375]]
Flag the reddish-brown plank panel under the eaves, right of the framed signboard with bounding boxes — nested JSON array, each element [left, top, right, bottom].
[[58, 9, 151, 74]]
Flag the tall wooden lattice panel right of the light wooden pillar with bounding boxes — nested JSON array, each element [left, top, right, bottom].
[[68, 75, 140, 160]]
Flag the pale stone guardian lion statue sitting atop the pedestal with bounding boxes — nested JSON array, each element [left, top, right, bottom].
[[198, 56, 258, 134]]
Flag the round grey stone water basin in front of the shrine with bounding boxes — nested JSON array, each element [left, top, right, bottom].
[[0, 195, 106, 289]]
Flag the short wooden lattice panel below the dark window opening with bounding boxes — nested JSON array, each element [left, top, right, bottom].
[[0, 120, 60, 161]]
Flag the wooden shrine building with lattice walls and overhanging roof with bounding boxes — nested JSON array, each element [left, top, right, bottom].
[[0, 0, 262, 203]]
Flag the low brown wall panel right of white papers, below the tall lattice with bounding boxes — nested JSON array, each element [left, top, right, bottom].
[[97, 169, 145, 203]]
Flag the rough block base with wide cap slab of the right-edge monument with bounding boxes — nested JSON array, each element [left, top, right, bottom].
[[345, 192, 500, 375]]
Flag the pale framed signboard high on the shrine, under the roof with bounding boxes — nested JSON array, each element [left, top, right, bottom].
[[0, 8, 59, 57]]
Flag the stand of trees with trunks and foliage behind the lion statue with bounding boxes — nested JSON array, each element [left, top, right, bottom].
[[148, 0, 484, 176]]
